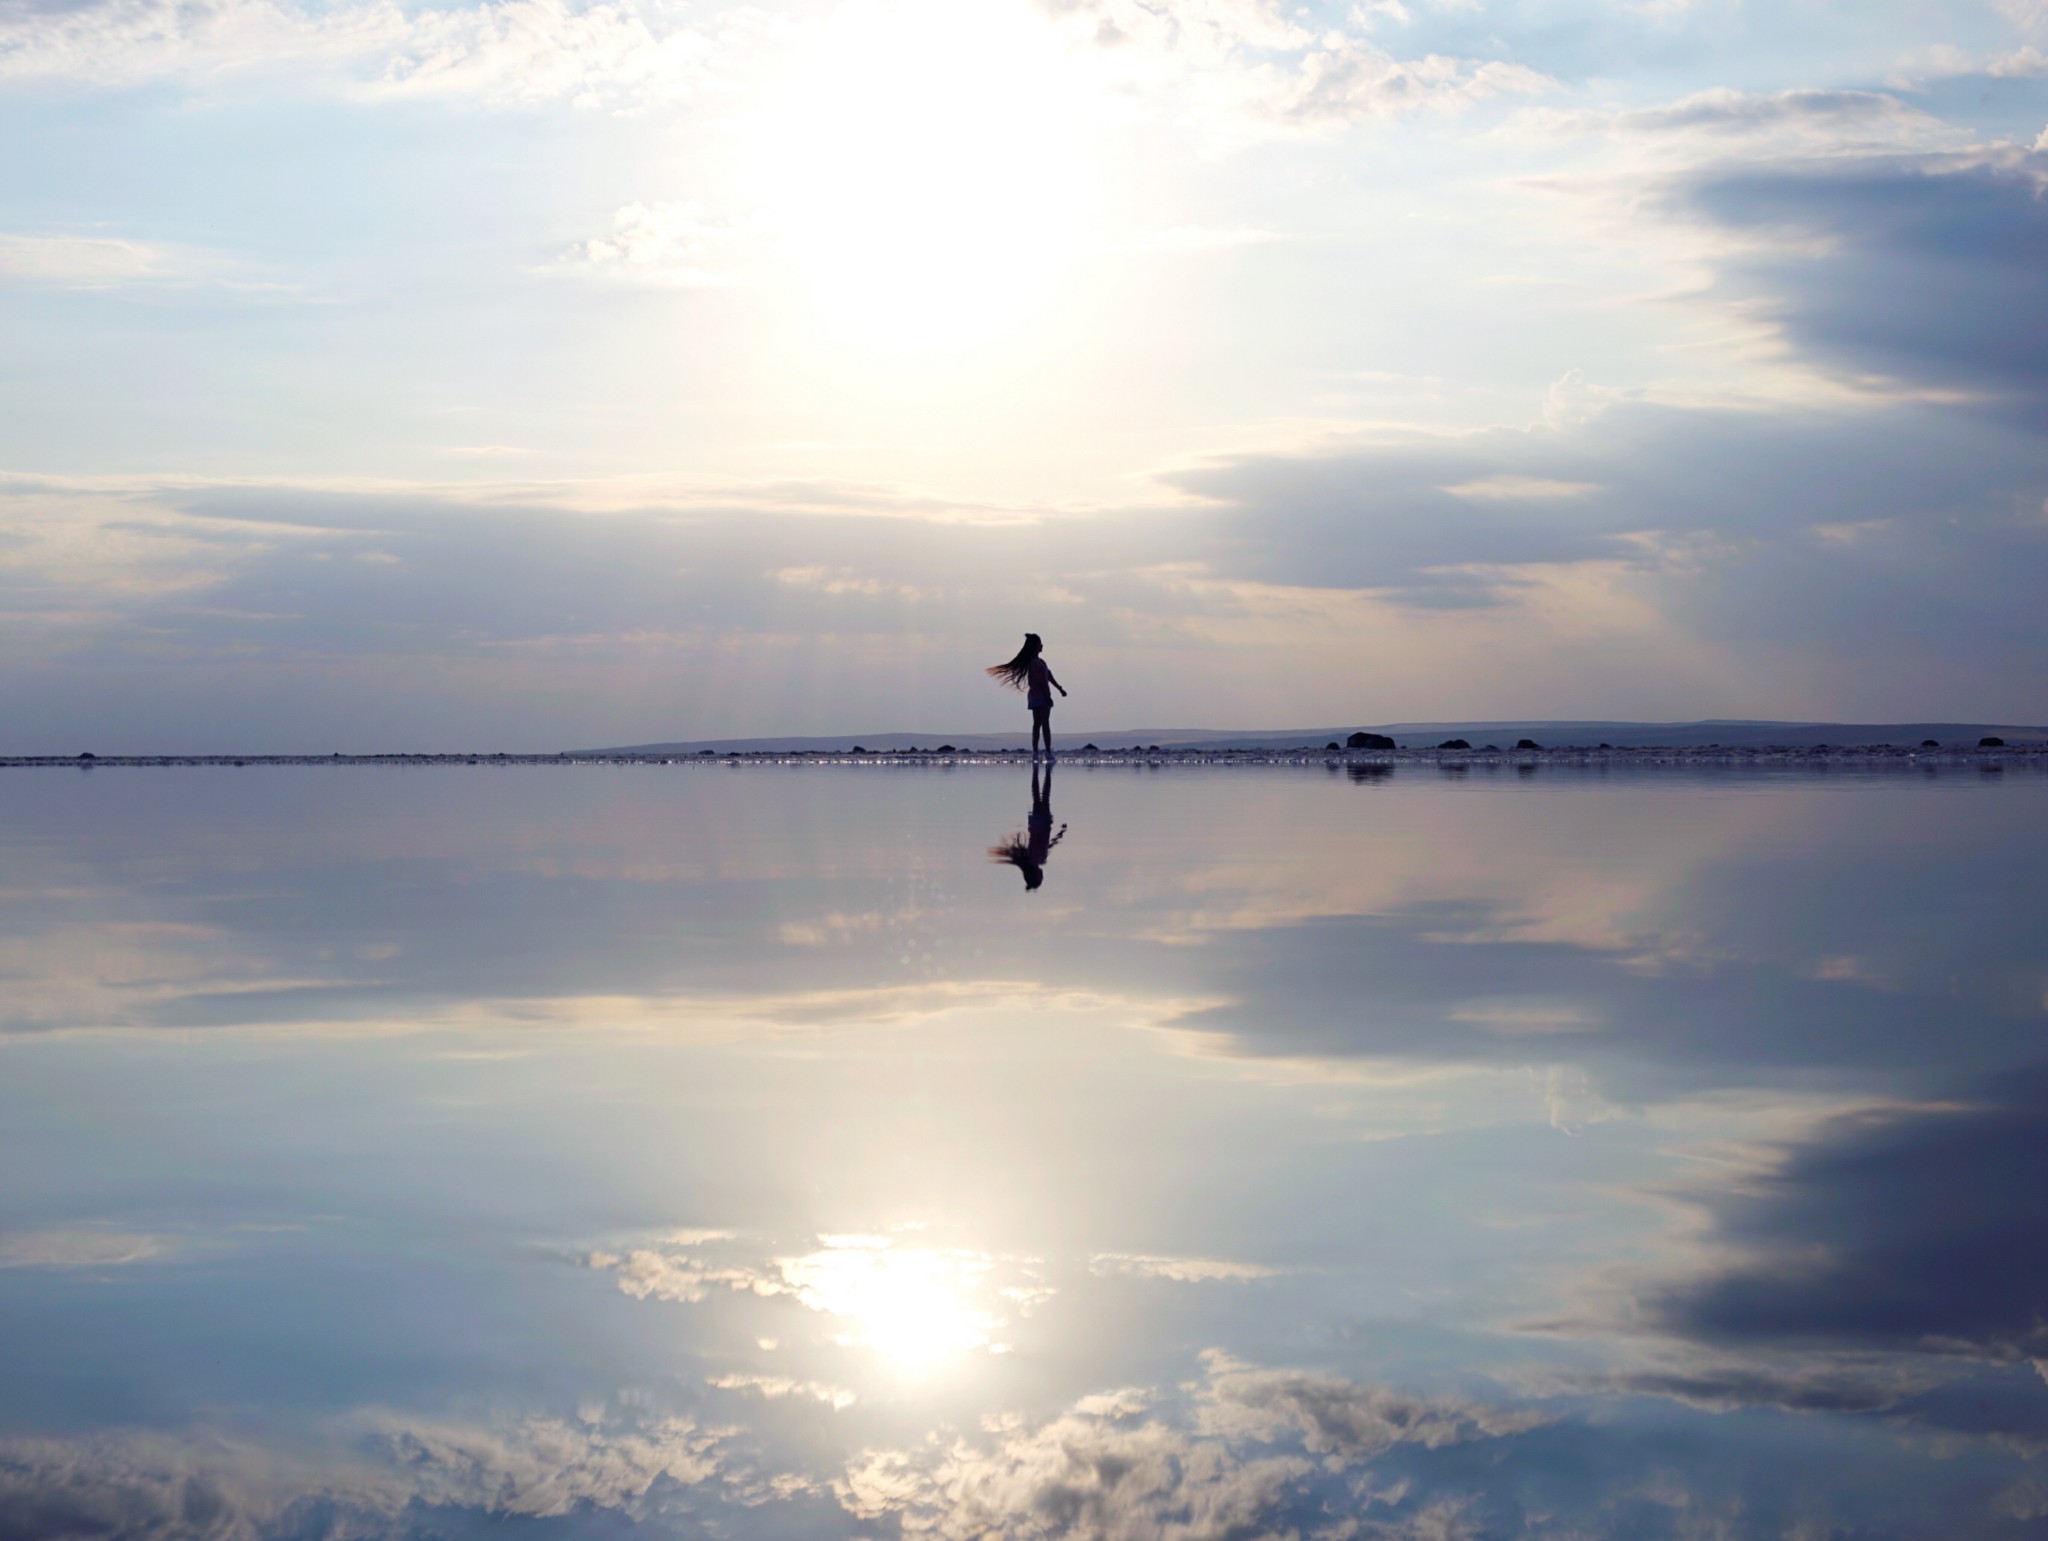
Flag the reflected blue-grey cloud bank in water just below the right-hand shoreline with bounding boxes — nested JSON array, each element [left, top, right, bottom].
[[1147, 774, 2040, 1098]]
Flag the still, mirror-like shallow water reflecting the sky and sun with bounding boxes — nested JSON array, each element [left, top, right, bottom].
[[0, 766, 2048, 1539]]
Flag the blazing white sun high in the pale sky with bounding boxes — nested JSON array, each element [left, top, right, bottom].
[[750, 0, 1092, 352]]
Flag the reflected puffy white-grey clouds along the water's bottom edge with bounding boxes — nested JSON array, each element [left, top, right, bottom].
[[0, 1357, 1536, 1541]]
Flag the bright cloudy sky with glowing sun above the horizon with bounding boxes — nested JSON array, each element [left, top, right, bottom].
[[0, 0, 2048, 754]]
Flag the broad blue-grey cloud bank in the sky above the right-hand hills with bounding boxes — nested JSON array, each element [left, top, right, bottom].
[[1165, 385, 2048, 719]]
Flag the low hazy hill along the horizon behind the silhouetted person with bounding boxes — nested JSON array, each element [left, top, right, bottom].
[[575, 717, 2048, 754]]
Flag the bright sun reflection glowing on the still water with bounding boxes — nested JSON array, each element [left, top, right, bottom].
[[780, 1236, 1006, 1375]]
